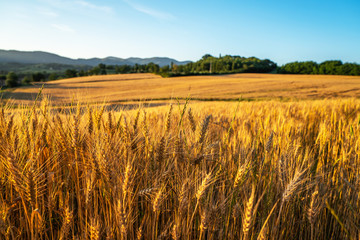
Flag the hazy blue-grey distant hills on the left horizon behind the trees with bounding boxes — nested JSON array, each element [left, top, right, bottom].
[[0, 50, 190, 67]]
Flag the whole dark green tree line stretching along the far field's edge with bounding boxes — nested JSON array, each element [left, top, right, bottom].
[[0, 54, 360, 87]]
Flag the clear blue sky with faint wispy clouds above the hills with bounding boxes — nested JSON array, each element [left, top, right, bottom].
[[0, 0, 360, 65]]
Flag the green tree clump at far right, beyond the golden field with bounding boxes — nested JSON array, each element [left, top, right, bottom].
[[278, 60, 360, 76]]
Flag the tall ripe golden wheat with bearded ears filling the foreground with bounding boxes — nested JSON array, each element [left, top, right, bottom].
[[0, 94, 360, 239]]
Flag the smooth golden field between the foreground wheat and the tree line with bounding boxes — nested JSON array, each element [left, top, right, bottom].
[[4, 74, 360, 104]]
